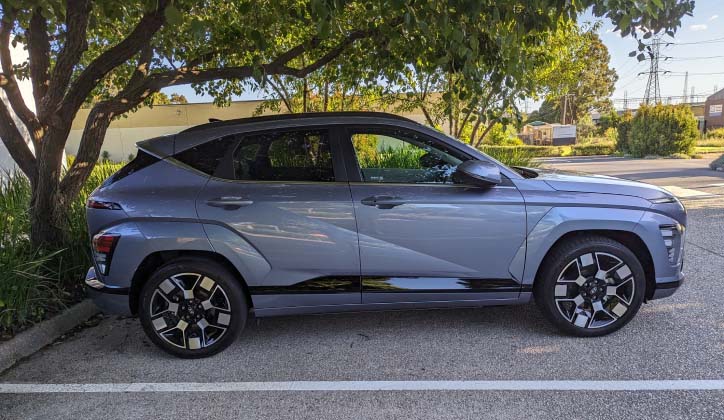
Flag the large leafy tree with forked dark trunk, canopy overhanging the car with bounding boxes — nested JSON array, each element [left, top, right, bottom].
[[0, 0, 694, 245]]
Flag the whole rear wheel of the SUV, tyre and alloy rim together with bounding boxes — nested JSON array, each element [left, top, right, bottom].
[[138, 258, 248, 359]]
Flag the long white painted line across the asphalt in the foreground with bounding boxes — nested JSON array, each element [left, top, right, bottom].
[[0, 379, 724, 394]]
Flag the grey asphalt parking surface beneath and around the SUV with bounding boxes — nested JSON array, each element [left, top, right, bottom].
[[0, 161, 724, 419]]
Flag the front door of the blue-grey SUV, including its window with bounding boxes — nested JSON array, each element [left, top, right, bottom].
[[345, 127, 526, 303]]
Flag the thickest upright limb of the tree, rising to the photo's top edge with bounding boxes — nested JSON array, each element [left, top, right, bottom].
[[36, 0, 91, 121]]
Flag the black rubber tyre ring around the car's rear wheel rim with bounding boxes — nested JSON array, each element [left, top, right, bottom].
[[138, 259, 248, 359]]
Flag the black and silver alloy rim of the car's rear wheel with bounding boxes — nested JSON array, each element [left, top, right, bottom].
[[149, 273, 231, 350]]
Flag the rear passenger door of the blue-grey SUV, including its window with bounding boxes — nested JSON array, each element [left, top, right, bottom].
[[188, 127, 360, 310]]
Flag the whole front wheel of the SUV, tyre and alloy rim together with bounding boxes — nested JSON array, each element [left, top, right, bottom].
[[533, 235, 646, 337]]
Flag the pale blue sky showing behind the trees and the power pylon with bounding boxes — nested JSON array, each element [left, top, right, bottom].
[[163, 0, 724, 110]]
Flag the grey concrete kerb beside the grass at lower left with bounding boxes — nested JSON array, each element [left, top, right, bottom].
[[0, 299, 99, 373]]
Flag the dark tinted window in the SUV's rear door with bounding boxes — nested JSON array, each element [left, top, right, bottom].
[[233, 130, 334, 182]]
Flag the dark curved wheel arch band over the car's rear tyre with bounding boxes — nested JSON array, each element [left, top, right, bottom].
[[128, 250, 254, 315]]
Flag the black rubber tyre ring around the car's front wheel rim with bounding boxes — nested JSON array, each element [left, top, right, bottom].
[[534, 241, 646, 337]]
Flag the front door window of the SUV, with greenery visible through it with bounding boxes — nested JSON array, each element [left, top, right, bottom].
[[352, 129, 467, 184]]
